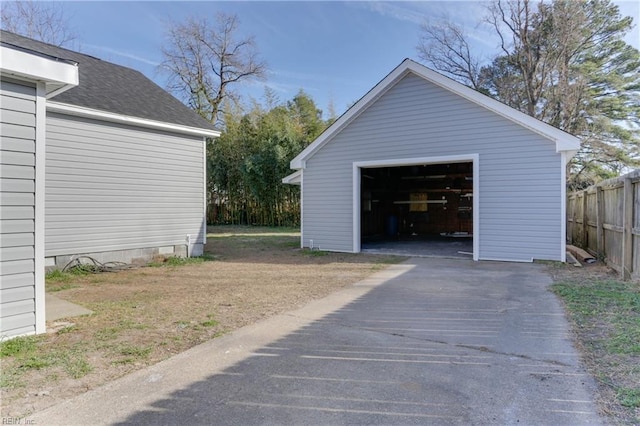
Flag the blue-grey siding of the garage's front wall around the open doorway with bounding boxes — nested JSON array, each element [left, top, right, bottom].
[[302, 74, 562, 261]]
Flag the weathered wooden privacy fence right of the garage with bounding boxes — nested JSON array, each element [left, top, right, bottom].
[[567, 169, 640, 279]]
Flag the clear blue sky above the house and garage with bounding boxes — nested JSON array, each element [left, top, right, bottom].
[[57, 1, 640, 118]]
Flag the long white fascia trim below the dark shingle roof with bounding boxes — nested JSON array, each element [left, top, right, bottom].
[[47, 102, 220, 138]]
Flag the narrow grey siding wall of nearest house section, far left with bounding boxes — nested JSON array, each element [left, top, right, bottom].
[[0, 81, 36, 337]]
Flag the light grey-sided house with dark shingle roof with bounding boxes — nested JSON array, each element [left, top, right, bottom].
[[0, 31, 219, 336]]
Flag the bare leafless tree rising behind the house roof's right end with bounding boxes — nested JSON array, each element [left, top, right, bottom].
[[161, 12, 267, 123]]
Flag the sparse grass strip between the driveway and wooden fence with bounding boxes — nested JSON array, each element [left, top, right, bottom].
[[552, 266, 640, 424]]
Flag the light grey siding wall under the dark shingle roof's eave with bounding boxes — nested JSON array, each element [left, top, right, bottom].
[[45, 113, 206, 266]]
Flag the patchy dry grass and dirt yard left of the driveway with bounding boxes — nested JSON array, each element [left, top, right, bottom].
[[1, 227, 403, 417]]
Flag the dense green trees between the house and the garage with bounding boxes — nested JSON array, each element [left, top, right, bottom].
[[208, 91, 327, 226]]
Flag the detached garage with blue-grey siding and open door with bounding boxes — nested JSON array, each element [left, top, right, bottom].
[[283, 59, 579, 262]]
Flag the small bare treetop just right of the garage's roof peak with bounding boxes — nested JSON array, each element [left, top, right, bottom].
[[417, 17, 480, 90]]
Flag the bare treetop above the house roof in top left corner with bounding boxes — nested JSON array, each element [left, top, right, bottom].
[[0, 0, 77, 46]]
